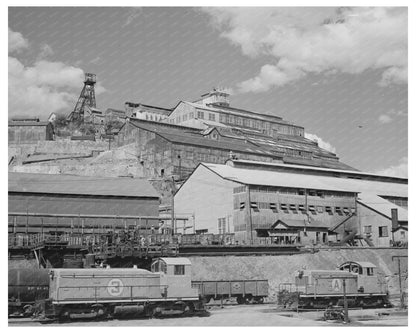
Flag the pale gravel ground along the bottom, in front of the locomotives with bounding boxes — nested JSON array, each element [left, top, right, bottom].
[[9, 304, 408, 327]]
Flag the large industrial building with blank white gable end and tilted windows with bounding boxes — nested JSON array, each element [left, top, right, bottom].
[[174, 160, 408, 246]]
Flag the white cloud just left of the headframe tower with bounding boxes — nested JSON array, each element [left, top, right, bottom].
[[8, 28, 105, 117]]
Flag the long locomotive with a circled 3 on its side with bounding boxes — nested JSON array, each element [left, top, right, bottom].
[[38, 258, 203, 319]]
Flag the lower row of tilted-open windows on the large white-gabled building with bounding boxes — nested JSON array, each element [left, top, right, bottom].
[[234, 202, 355, 215]]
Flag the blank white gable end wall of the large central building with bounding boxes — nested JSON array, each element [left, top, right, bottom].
[[175, 167, 236, 233]]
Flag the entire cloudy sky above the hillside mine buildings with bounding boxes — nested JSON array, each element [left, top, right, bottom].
[[9, 7, 408, 176]]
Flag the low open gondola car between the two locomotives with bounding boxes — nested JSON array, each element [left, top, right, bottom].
[[192, 280, 269, 304]]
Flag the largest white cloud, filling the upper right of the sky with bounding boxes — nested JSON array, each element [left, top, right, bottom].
[[202, 7, 407, 92]]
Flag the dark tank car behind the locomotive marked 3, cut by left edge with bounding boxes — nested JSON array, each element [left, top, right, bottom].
[[8, 268, 49, 316]]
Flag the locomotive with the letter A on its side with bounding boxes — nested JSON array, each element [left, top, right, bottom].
[[278, 261, 390, 308]]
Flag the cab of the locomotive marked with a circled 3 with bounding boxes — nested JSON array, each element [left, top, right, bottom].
[[151, 258, 199, 299]]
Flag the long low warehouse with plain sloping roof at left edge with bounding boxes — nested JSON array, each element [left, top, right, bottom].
[[8, 172, 159, 232]]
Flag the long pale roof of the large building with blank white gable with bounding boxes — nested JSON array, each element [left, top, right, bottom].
[[198, 163, 408, 197]]
